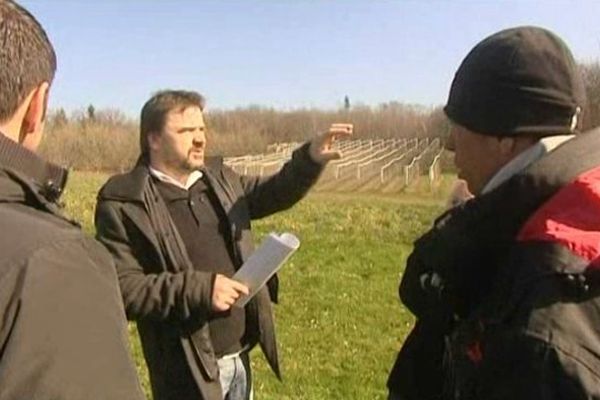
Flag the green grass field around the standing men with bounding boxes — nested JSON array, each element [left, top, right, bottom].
[[63, 173, 451, 400]]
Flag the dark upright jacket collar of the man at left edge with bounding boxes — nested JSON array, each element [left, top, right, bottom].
[[0, 133, 68, 203]]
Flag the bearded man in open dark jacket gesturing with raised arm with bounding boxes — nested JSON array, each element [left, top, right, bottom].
[[96, 90, 352, 400]]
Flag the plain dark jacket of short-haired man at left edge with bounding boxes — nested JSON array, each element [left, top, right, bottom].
[[0, 134, 143, 400]]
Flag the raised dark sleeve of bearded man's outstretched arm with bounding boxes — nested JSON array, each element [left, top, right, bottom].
[[240, 143, 324, 219]]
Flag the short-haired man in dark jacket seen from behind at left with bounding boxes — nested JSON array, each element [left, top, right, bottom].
[[0, 0, 143, 400]]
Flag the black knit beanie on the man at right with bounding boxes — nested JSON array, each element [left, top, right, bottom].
[[444, 27, 585, 137]]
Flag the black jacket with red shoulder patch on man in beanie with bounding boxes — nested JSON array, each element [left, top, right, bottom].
[[388, 131, 600, 400]]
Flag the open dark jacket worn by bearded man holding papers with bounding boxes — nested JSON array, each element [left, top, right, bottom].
[[96, 145, 322, 400]]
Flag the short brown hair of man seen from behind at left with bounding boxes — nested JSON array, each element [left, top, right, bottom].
[[0, 0, 56, 121]]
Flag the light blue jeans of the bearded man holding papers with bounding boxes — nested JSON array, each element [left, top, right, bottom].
[[217, 353, 253, 400]]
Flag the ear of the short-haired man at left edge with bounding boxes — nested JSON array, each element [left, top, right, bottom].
[[19, 82, 50, 151]]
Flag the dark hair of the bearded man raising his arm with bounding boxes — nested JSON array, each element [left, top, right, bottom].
[[140, 90, 205, 156]]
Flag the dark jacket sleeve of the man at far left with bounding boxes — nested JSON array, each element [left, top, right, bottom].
[[0, 238, 143, 400]]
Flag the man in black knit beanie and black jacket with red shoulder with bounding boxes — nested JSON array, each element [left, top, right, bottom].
[[388, 27, 600, 400]]
